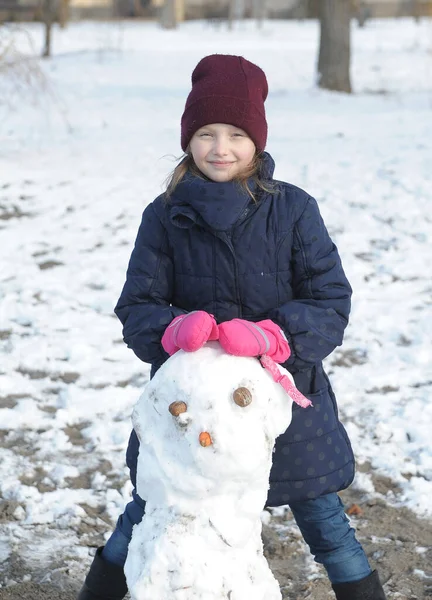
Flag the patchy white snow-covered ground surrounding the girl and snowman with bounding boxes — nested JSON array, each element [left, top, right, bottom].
[[0, 20, 432, 580]]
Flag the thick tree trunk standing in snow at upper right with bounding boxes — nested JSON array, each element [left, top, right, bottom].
[[318, 0, 351, 94]]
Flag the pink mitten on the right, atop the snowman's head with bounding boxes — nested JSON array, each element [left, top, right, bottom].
[[219, 319, 291, 363]]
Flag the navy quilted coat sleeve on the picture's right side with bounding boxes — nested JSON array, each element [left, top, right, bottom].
[[269, 197, 352, 369]]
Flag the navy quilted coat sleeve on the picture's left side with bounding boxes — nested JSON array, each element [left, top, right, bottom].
[[114, 204, 186, 367]]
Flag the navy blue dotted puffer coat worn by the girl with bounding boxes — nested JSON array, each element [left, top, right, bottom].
[[115, 155, 354, 506]]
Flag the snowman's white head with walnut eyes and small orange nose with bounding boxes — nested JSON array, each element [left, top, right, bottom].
[[133, 342, 292, 498]]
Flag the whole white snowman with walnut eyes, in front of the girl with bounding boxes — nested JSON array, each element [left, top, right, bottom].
[[125, 342, 302, 600]]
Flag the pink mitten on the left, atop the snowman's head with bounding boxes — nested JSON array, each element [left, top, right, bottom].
[[162, 310, 219, 356]]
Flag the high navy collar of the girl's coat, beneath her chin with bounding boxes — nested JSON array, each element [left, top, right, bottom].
[[170, 153, 274, 231]]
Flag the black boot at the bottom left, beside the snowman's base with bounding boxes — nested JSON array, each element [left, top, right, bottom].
[[77, 546, 127, 600]]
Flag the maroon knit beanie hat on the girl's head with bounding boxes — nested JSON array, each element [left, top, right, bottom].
[[181, 54, 268, 151]]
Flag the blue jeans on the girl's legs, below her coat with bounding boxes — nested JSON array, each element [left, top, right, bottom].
[[102, 491, 372, 583]]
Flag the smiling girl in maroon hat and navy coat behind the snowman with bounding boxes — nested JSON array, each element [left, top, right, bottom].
[[78, 55, 385, 600]]
